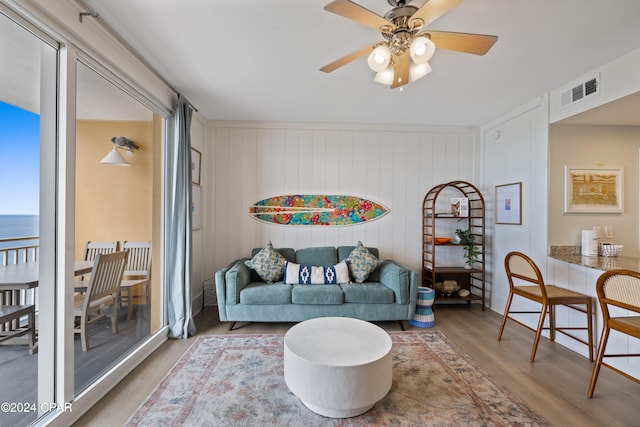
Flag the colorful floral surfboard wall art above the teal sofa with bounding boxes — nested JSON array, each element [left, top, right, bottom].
[[249, 194, 389, 226]]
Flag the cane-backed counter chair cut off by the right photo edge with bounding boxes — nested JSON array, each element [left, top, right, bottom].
[[587, 270, 640, 397]]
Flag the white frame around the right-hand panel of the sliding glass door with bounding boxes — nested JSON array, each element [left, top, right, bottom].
[[0, 1, 176, 425]]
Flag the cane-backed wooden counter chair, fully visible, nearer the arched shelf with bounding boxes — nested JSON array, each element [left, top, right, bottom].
[[498, 251, 593, 363]]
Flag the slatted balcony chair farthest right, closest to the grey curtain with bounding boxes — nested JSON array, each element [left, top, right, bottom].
[[120, 241, 151, 320]]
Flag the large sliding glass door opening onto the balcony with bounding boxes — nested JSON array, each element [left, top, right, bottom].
[[0, 4, 170, 426]]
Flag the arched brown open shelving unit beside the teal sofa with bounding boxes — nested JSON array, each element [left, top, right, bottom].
[[422, 181, 485, 311]]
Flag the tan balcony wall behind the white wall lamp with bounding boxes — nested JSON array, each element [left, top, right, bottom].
[[75, 120, 154, 259]]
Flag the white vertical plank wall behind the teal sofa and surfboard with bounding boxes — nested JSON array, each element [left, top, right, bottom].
[[207, 122, 477, 271]]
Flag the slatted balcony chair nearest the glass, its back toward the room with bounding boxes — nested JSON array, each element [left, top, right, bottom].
[[73, 251, 127, 351]]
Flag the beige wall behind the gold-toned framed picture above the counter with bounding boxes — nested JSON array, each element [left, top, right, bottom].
[[541, 125, 640, 257]]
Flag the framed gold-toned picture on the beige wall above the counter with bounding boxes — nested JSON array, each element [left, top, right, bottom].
[[564, 166, 624, 213]]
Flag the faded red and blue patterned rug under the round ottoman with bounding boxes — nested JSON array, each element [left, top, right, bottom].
[[127, 331, 547, 427]]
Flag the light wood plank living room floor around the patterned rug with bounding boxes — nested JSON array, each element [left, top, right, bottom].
[[74, 304, 640, 427]]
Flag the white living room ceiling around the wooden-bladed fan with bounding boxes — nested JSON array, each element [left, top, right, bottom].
[[79, 0, 640, 126]]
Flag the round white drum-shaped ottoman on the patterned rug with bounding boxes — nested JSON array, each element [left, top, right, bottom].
[[284, 317, 393, 418]]
